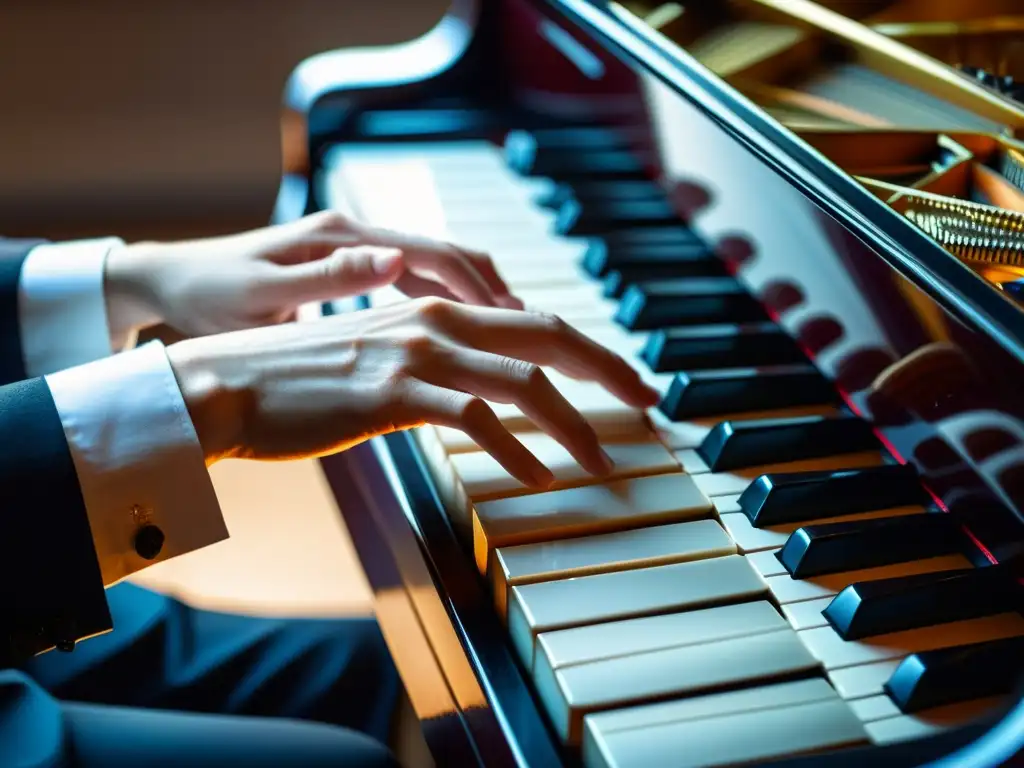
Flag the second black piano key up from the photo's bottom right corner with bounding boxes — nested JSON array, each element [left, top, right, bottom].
[[821, 565, 1021, 640]]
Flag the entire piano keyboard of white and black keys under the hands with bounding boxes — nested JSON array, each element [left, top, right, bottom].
[[321, 127, 1024, 768]]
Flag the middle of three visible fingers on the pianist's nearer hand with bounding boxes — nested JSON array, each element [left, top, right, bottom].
[[420, 348, 614, 476]]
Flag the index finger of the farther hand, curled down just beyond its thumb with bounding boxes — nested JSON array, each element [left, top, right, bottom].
[[348, 222, 498, 306]]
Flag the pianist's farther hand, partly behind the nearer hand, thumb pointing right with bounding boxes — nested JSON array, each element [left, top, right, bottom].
[[105, 212, 522, 337]]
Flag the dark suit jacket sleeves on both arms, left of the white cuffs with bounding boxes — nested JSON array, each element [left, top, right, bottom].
[[0, 239, 112, 669]]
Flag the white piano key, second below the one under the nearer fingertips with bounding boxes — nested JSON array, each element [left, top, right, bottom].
[[488, 520, 736, 618]]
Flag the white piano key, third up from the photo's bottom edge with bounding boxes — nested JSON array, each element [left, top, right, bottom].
[[535, 628, 817, 745]]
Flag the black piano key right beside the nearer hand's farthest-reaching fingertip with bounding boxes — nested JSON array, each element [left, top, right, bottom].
[[658, 364, 836, 421]]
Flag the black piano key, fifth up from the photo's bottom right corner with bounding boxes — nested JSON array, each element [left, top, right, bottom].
[[697, 414, 882, 472]]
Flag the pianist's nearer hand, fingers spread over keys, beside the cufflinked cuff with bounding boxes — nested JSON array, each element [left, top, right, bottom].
[[168, 298, 658, 487]]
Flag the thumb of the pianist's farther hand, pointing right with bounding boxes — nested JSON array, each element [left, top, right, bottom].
[[281, 246, 406, 302]]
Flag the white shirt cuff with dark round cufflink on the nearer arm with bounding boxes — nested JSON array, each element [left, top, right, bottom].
[[46, 342, 227, 586]]
